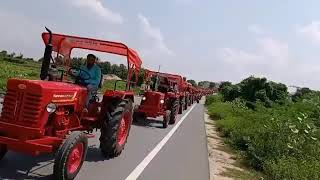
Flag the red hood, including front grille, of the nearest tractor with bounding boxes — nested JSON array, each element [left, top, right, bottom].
[[0, 79, 87, 127]]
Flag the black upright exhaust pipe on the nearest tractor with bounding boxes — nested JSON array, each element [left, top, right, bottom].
[[40, 27, 53, 80]]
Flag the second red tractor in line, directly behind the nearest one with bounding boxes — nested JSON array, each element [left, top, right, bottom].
[[134, 70, 182, 128]]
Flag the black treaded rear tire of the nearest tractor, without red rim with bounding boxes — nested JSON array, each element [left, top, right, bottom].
[[99, 99, 132, 158]]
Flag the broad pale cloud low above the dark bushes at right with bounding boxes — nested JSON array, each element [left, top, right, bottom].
[[217, 37, 297, 82]]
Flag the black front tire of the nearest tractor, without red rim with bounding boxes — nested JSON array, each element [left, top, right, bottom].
[[53, 131, 88, 180]]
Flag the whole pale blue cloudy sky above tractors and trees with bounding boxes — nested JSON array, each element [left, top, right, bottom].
[[0, 0, 320, 90]]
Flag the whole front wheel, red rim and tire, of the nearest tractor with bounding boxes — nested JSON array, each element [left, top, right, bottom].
[[53, 131, 88, 180]]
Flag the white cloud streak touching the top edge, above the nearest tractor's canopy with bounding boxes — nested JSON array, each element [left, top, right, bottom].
[[70, 0, 123, 24]]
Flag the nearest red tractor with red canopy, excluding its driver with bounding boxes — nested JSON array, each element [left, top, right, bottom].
[[0, 29, 142, 179]]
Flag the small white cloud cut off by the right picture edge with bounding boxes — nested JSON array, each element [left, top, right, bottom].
[[297, 21, 320, 44]]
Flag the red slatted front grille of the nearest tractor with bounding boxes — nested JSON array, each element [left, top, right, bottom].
[[1, 89, 42, 124]]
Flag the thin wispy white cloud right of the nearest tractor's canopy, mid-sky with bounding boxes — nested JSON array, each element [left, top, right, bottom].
[[138, 14, 174, 55]]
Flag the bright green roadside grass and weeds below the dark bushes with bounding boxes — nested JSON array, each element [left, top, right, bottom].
[[206, 95, 320, 180]]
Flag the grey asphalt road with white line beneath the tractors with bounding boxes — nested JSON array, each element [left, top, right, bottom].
[[0, 97, 209, 180]]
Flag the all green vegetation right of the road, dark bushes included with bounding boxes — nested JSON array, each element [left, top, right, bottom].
[[206, 77, 320, 179]]
